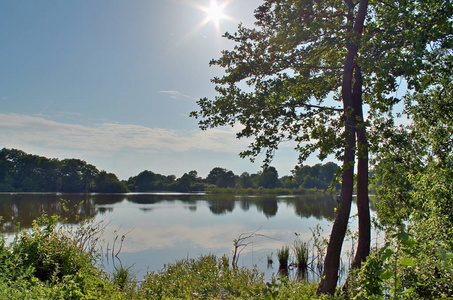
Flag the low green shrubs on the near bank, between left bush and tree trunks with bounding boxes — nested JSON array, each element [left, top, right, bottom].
[[138, 255, 341, 300]]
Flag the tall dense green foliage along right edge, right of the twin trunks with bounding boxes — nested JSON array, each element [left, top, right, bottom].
[[370, 27, 453, 299]]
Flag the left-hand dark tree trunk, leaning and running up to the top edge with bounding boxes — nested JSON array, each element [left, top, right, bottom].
[[317, 0, 368, 295]]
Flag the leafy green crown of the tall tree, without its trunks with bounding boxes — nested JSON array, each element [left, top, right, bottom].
[[191, 0, 451, 163]]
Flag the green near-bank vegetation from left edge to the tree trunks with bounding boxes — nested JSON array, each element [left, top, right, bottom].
[[0, 215, 340, 299]]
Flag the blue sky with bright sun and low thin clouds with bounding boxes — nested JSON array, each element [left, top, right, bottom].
[[0, 0, 319, 179]]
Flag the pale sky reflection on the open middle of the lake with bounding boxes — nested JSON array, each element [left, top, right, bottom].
[[96, 201, 346, 282]]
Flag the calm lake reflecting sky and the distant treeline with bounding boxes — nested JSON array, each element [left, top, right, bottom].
[[0, 193, 378, 280]]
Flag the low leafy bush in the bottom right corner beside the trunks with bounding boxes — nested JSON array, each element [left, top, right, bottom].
[[349, 228, 453, 299]]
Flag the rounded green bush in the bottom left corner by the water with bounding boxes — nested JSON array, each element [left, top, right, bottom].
[[0, 215, 122, 299]]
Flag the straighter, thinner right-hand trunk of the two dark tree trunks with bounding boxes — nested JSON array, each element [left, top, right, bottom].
[[351, 65, 371, 268]]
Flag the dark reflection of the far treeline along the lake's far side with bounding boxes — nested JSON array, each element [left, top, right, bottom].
[[0, 193, 336, 233]]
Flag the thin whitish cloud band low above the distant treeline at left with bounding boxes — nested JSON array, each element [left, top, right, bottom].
[[0, 114, 247, 156]]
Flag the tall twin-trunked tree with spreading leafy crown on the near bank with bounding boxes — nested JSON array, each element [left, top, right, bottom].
[[192, 0, 451, 294]]
